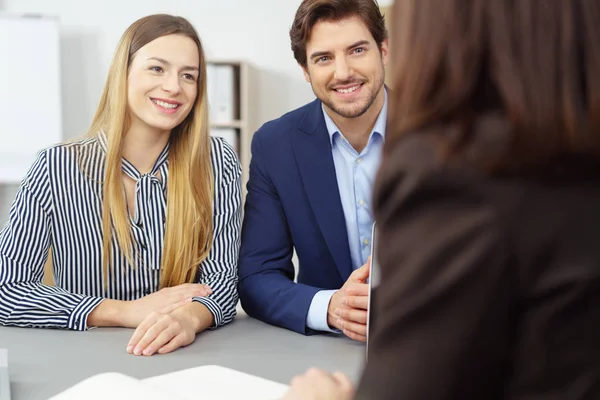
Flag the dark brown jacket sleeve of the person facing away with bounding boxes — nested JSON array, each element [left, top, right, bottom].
[[357, 148, 514, 400]]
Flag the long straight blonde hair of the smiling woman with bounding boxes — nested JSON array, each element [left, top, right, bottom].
[[88, 14, 214, 288]]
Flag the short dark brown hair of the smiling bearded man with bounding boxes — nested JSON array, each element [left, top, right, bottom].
[[290, 0, 388, 68]]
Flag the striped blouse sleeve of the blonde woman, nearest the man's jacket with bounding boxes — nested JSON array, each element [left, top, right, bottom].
[[194, 139, 242, 329]]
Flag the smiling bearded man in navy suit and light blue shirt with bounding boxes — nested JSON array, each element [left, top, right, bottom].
[[239, 0, 388, 341]]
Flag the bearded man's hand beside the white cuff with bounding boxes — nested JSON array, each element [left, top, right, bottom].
[[327, 257, 371, 342]]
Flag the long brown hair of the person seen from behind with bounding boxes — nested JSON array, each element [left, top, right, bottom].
[[386, 0, 600, 169]]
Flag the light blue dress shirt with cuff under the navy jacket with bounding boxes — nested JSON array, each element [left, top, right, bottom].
[[306, 92, 387, 332]]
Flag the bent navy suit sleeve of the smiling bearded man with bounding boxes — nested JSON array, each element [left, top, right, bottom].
[[239, 131, 320, 334]]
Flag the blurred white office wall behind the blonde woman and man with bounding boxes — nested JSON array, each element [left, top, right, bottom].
[[0, 0, 392, 225]]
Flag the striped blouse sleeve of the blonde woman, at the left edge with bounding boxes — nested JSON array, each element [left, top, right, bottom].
[[0, 152, 102, 330]]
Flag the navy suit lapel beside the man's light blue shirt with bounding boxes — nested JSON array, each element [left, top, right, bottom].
[[293, 100, 352, 280]]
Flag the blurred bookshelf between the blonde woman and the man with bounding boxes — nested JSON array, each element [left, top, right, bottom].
[[207, 59, 260, 200]]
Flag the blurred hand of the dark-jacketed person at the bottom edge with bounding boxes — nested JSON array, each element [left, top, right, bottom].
[[283, 368, 354, 400]]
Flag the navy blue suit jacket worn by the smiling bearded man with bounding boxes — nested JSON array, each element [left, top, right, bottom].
[[239, 100, 352, 334]]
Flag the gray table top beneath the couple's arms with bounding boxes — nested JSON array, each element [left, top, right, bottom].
[[0, 313, 365, 400]]
